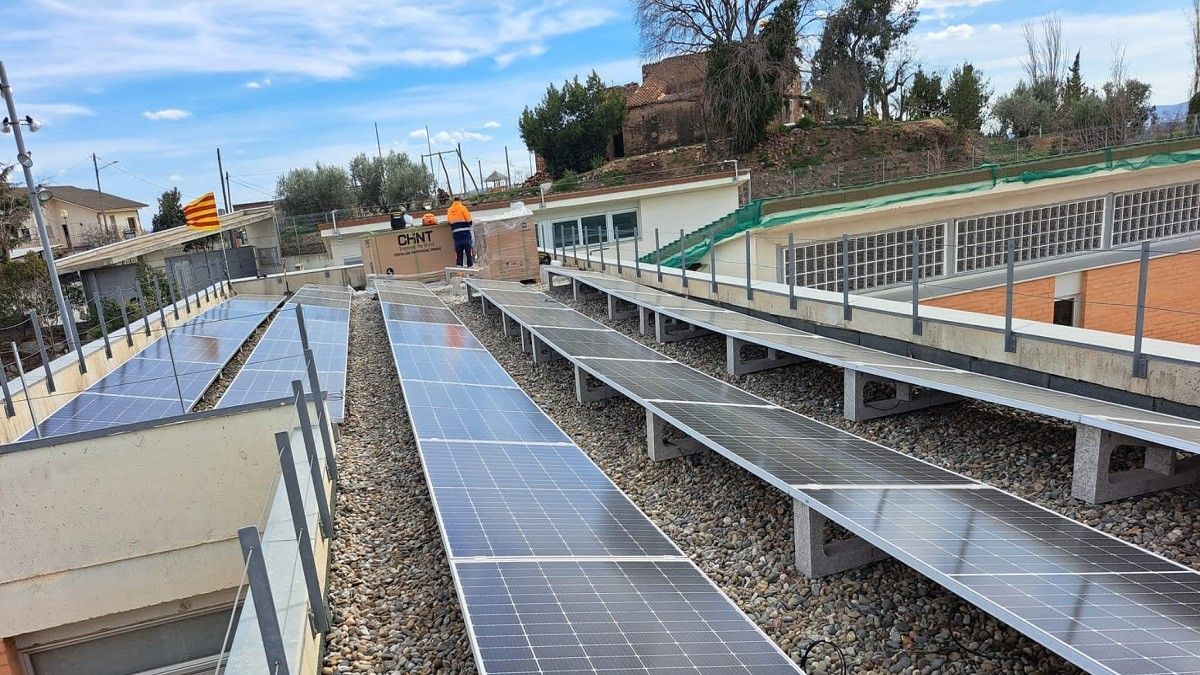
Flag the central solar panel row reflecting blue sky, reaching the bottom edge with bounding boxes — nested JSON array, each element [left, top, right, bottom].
[[374, 280, 798, 674]]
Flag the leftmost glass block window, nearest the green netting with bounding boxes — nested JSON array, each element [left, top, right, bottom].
[[781, 222, 946, 291]]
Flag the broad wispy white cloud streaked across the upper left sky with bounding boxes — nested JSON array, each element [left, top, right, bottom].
[[4, 0, 624, 86]]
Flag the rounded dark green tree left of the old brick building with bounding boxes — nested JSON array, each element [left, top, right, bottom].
[[518, 71, 626, 177]]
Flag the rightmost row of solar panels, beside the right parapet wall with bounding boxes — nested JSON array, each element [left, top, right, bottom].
[[551, 267, 1200, 453]]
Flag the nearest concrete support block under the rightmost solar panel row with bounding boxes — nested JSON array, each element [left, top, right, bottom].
[[1070, 424, 1200, 504]]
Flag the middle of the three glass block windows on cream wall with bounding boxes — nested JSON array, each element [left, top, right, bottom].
[[955, 198, 1104, 271]]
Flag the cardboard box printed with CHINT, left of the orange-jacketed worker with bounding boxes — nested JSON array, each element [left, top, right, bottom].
[[360, 225, 455, 280]]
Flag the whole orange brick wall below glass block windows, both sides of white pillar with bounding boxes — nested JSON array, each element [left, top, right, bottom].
[[923, 251, 1200, 345]]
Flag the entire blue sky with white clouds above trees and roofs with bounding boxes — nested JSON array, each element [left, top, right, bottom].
[[0, 0, 1190, 221]]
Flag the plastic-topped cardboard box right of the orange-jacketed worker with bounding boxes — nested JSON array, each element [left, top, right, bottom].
[[473, 202, 538, 281]]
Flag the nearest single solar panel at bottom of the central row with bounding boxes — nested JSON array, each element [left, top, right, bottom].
[[454, 560, 797, 675]]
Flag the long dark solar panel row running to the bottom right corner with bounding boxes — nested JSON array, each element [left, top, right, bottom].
[[466, 280, 1200, 674]]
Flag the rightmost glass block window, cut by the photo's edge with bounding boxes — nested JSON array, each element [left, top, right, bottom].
[[1112, 183, 1200, 246]]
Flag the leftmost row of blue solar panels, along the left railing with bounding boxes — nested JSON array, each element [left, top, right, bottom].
[[20, 295, 280, 441]]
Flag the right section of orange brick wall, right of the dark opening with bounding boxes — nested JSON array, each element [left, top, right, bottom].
[[1082, 251, 1200, 345]]
